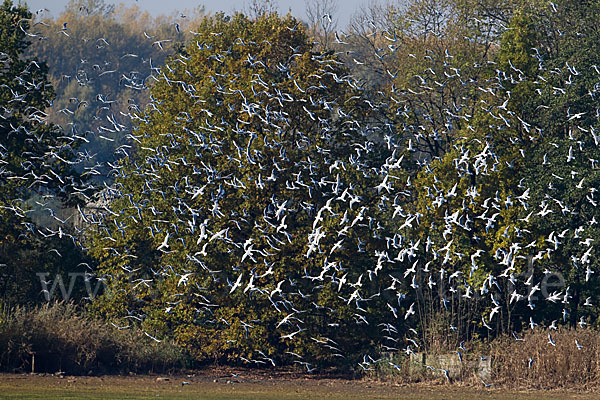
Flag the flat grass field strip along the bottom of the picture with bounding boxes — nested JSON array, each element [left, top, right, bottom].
[[0, 374, 599, 400]]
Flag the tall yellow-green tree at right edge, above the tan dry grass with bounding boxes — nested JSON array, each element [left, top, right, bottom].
[[404, 3, 598, 350]]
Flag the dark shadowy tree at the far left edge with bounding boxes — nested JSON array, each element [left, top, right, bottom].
[[0, 0, 89, 304]]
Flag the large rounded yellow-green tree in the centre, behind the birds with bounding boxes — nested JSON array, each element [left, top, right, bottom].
[[91, 14, 385, 369]]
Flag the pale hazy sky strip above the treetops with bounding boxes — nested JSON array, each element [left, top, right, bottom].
[[21, 0, 369, 29]]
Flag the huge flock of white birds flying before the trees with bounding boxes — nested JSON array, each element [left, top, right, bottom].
[[0, 3, 600, 386]]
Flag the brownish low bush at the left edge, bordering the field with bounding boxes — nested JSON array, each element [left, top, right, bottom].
[[0, 303, 189, 374]]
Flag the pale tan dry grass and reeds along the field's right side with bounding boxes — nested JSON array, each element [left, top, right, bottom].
[[366, 328, 600, 390]]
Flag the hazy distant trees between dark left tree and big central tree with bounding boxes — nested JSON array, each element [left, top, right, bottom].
[[28, 0, 195, 184]]
